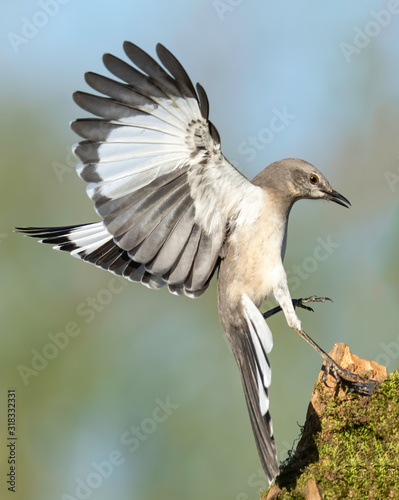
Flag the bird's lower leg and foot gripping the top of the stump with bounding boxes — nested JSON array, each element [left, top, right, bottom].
[[295, 329, 378, 395]]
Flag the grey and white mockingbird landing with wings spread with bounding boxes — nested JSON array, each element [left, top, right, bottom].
[[18, 42, 376, 481]]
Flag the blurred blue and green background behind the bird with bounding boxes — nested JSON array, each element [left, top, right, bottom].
[[0, 0, 399, 500]]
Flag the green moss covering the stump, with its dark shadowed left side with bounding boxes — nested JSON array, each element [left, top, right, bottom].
[[266, 371, 399, 500]]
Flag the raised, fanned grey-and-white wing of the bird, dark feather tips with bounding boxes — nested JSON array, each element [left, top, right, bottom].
[[64, 42, 262, 296]]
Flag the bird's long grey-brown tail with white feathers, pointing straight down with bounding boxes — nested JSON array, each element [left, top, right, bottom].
[[233, 298, 279, 483]]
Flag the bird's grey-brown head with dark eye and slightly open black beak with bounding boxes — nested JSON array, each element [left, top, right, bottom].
[[252, 158, 350, 208]]
